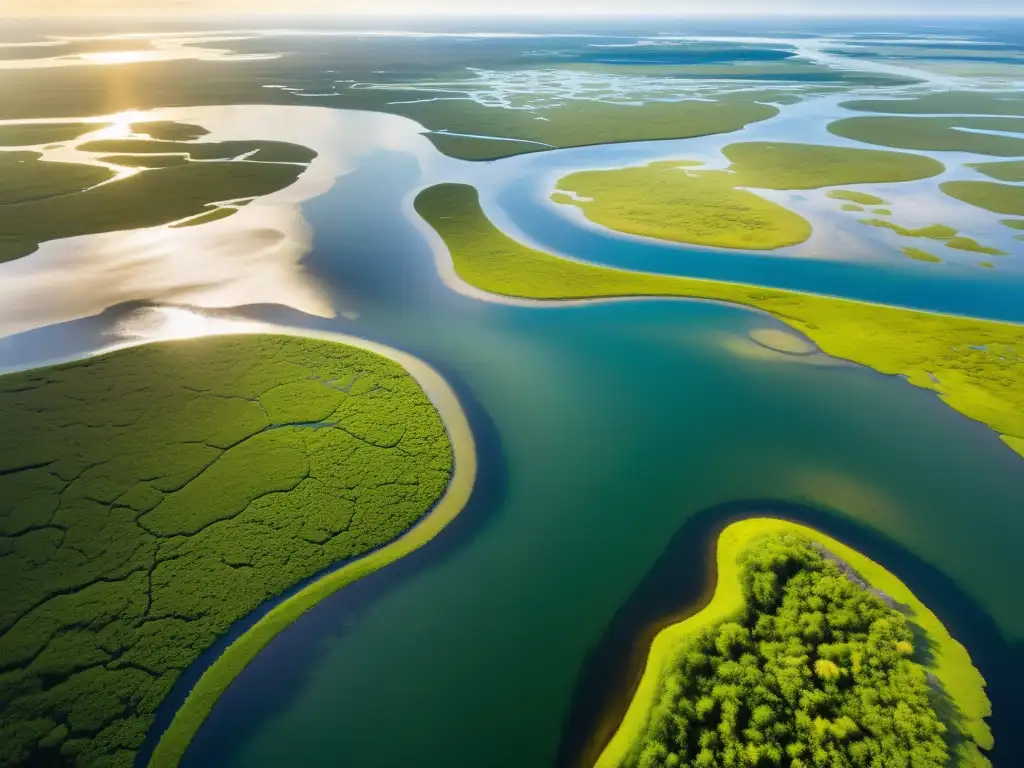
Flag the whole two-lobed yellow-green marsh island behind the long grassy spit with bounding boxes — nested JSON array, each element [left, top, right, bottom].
[[552, 141, 942, 250]]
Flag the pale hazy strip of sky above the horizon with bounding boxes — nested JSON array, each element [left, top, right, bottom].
[[0, 0, 1024, 17]]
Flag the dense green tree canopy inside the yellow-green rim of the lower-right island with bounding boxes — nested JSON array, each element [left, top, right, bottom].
[[632, 534, 950, 768]]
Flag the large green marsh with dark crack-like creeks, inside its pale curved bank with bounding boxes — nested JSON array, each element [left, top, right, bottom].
[[0, 336, 453, 768]]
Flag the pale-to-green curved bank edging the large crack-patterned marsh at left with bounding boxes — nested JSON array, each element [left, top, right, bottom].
[[81, 324, 485, 768]]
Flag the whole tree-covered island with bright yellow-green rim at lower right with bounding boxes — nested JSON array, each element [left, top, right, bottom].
[[597, 518, 992, 768]]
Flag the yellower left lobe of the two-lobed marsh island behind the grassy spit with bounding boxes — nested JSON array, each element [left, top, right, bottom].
[[553, 161, 811, 250]]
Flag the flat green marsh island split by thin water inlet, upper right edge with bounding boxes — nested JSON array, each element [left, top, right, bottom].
[[828, 117, 1024, 158]]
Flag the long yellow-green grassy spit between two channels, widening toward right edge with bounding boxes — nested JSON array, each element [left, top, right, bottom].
[[416, 184, 1024, 455]]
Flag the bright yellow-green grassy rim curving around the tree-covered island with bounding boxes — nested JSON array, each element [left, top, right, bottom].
[[595, 518, 992, 768]]
